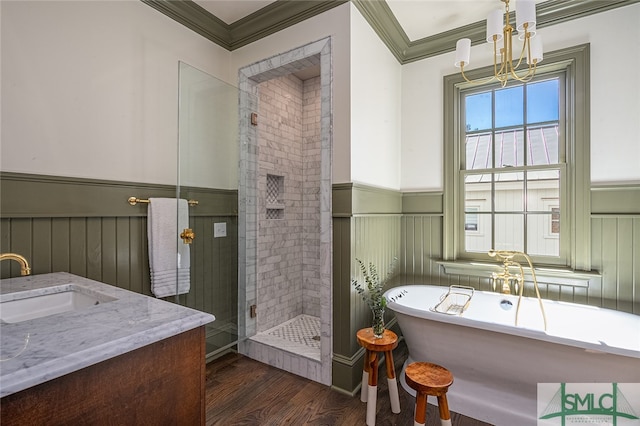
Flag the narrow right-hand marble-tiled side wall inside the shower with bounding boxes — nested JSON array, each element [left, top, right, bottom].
[[302, 76, 322, 317]]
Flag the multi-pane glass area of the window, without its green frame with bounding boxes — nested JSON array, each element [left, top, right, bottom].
[[460, 75, 565, 263]]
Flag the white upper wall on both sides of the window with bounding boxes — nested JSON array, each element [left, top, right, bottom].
[[401, 4, 640, 191]]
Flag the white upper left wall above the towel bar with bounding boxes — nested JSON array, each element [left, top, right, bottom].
[[0, 1, 232, 184]]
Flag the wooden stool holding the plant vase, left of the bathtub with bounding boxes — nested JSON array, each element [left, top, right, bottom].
[[357, 327, 400, 426]]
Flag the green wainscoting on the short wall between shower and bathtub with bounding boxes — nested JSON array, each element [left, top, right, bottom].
[[332, 184, 402, 394]]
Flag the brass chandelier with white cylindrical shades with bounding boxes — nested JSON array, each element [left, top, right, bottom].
[[455, 0, 542, 87]]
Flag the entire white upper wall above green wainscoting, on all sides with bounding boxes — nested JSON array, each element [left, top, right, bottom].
[[0, 1, 640, 191]]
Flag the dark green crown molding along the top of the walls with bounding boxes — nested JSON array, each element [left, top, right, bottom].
[[140, 0, 640, 61]]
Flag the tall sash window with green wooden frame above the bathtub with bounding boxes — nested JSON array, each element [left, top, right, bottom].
[[444, 45, 591, 270]]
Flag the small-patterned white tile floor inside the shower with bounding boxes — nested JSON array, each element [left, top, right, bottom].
[[251, 315, 320, 360]]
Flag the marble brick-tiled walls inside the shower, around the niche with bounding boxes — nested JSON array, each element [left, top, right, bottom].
[[257, 75, 320, 332]]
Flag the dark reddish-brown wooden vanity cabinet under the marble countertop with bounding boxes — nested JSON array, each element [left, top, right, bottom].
[[0, 326, 205, 426]]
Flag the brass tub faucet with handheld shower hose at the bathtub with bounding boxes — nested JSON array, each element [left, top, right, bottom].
[[487, 249, 547, 331]]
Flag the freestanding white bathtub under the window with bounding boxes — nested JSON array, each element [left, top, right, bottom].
[[385, 285, 640, 426]]
